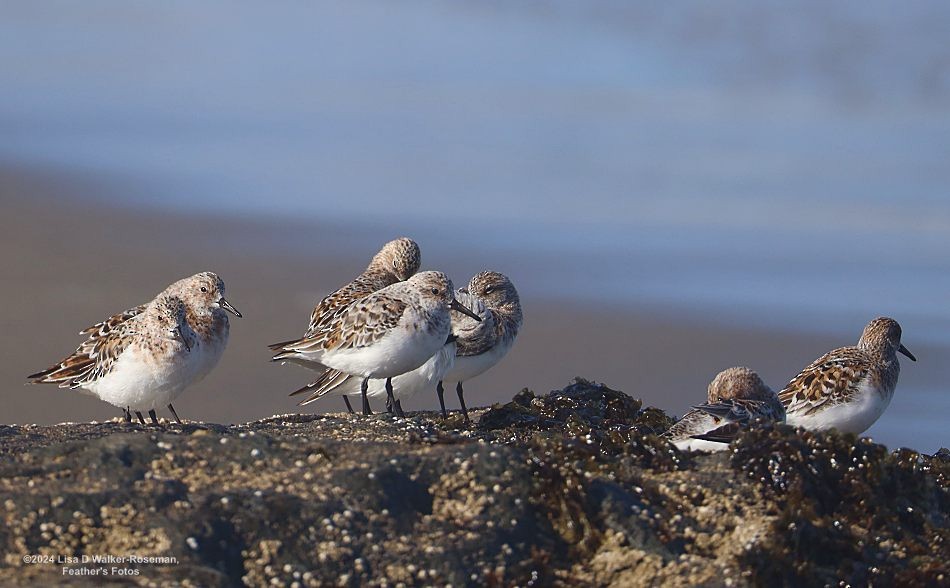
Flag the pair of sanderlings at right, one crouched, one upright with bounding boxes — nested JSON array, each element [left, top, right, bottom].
[[664, 317, 917, 451]]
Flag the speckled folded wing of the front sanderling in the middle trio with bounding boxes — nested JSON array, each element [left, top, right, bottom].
[[275, 292, 408, 359]]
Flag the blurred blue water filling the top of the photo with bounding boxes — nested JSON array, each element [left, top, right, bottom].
[[0, 0, 950, 446]]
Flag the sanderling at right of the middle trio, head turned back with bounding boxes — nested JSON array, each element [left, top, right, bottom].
[[436, 271, 524, 421]]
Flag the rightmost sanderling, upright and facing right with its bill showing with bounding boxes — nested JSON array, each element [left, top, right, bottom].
[[779, 317, 917, 434]]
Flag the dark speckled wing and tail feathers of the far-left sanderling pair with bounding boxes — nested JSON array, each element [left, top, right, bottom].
[[27, 309, 138, 388]]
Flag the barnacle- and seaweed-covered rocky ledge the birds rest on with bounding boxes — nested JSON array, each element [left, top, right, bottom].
[[0, 380, 950, 586]]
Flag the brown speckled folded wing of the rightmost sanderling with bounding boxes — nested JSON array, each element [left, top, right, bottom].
[[778, 347, 873, 415]]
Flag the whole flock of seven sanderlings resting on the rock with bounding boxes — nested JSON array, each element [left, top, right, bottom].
[[28, 238, 916, 451]]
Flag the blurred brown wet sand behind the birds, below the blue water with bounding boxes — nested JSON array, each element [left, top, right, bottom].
[[0, 168, 950, 450]]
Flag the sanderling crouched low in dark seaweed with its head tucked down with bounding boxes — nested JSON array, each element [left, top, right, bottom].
[[663, 367, 785, 451]]
